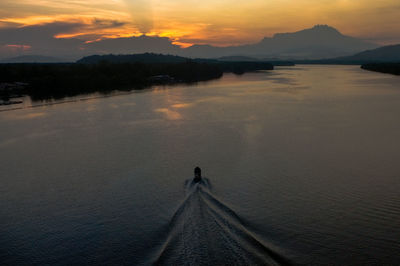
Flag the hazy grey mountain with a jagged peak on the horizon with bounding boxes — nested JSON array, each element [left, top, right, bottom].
[[180, 25, 378, 59]]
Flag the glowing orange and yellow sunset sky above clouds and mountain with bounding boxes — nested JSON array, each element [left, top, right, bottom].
[[0, 0, 400, 49]]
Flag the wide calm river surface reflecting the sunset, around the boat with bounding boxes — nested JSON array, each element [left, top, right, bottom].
[[0, 66, 400, 265]]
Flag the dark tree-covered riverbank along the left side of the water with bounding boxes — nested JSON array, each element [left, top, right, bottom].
[[0, 60, 273, 100]]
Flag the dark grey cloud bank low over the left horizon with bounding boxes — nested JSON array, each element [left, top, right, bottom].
[[0, 19, 180, 60]]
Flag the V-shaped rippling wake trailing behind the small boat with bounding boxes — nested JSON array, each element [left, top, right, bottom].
[[154, 178, 290, 265]]
